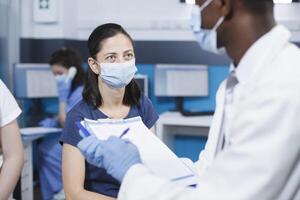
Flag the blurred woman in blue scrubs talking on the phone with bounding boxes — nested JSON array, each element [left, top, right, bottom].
[[38, 48, 84, 200]]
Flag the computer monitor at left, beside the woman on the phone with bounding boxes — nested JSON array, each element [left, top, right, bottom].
[[14, 63, 57, 98]]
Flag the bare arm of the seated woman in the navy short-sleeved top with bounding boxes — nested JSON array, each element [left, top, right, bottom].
[[62, 143, 114, 200]]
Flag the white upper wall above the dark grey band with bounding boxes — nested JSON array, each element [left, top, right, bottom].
[[21, 0, 300, 41]]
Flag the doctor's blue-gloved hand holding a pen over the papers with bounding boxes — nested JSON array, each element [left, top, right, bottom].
[[77, 136, 141, 182]]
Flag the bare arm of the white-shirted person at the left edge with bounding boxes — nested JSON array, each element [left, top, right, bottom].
[[0, 120, 24, 199]]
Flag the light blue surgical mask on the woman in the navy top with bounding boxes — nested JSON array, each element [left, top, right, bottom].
[[98, 59, 137, 88]]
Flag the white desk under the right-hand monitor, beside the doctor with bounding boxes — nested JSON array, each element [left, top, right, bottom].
[[156, 112, 212, 150]]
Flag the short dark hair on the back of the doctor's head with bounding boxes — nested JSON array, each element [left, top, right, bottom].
[[241, 0, 274, 15]]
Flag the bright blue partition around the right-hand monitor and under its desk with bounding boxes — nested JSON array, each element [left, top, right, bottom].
[[138, 64, 229, 161]]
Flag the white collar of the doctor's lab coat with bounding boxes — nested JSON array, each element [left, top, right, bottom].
[[230, 25, 291, 84]]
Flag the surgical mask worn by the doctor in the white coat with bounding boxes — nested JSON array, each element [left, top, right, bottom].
[[191, 0, 225, 54]]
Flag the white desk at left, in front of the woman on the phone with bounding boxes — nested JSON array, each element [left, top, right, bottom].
[[20, 127, 61, 200]]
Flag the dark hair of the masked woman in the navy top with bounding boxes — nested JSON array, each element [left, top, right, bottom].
[[82, 23, 141, 108]]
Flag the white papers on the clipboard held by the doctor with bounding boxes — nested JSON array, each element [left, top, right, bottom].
[[77, 117, 198, 186]]
